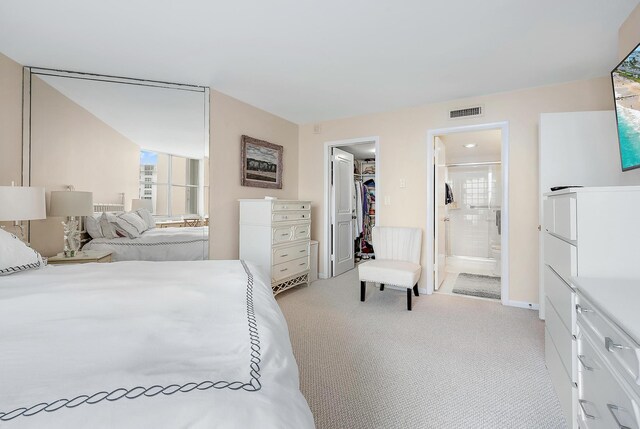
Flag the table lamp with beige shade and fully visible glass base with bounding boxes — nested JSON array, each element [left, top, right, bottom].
[[49, 189, 93, 258]]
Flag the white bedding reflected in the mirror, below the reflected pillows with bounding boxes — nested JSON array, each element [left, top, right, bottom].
[[83, 226, 209, 261]]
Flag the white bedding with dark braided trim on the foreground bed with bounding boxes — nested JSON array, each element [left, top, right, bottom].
[[0, 261, 313, 429]]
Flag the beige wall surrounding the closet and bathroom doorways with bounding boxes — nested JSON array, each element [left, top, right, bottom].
[[298, 77, 615, 303]]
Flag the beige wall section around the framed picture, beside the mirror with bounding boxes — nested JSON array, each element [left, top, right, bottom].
[[209, 90, 300, 259]]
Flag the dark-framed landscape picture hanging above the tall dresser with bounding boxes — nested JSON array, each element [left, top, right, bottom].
[[241, 136, 283, 189]]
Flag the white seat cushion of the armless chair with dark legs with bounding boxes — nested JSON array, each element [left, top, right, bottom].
[[358, 259, 422, 288]]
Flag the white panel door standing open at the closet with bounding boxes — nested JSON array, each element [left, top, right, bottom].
[[331, 148, 354, 276]]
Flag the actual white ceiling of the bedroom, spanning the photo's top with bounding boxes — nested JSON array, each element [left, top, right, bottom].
[[0, 0, 638, 123]]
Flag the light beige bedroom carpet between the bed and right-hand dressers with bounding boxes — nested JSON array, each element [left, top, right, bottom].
[[277, 270, 566, 429]]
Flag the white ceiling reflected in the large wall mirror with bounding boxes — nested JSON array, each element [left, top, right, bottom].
[[38, 75, 209, 159]]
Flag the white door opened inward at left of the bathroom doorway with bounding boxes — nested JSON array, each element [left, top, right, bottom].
[[433, 137, 449, 290]]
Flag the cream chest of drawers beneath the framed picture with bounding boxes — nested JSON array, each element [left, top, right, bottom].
[[240, 200, 311, 294]]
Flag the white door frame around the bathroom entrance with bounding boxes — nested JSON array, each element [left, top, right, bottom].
[[424, 121, 510, 305]]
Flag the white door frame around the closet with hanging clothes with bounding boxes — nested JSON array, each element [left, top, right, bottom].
[[318, 136, 382, 279]]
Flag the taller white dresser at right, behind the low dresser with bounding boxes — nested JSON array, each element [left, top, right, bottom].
[[543, 186, 640, 428]]
